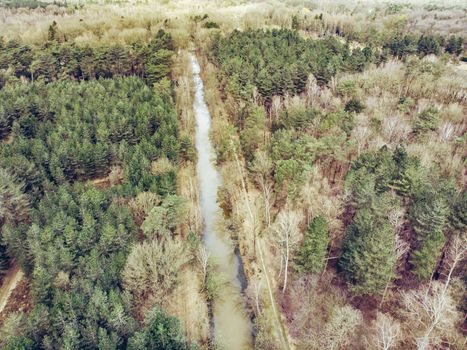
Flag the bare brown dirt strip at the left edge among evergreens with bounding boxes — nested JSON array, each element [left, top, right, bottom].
[[0, 265, 28, 324]]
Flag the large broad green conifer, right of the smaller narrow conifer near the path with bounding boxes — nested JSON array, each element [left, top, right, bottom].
[[339, 209, 397, 294]]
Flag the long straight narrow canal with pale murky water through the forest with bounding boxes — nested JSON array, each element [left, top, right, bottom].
[[191, 55, 252, 350]]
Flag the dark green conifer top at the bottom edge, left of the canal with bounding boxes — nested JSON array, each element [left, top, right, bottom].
[[128, 307, 197, 350]]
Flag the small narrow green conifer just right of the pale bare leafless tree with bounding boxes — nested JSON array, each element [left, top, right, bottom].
[[296, 216, 329, 273]]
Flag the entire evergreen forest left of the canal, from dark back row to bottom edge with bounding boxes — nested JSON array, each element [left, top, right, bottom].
[[0, 27, 197, 349]]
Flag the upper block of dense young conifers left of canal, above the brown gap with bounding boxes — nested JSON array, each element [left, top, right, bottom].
[[0, 77, 178, 192]]
